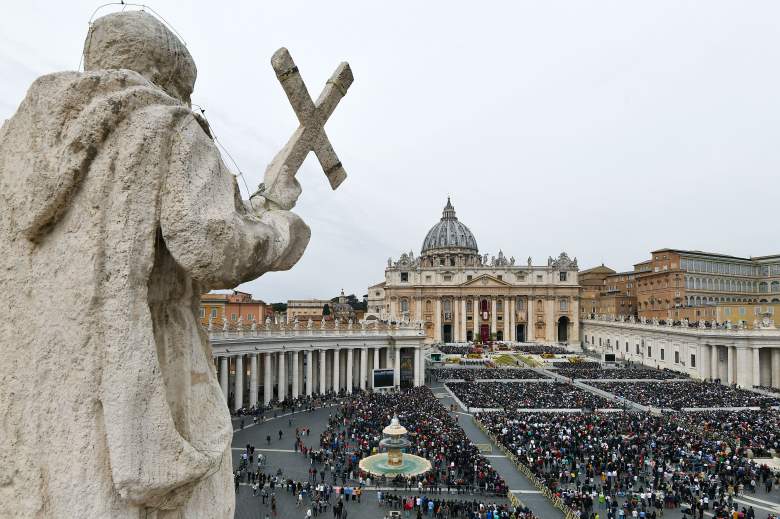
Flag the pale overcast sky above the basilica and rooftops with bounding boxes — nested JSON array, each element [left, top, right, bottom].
[[0, 0, 780, 302]]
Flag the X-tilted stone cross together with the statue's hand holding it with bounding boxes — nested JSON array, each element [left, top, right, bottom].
[[252, 47, 354, 209]]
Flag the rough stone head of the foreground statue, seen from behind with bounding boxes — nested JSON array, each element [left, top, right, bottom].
[[84, 11, 198, 104]]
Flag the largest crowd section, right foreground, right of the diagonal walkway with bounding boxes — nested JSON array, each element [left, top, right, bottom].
[[477, 411, 780, 519]]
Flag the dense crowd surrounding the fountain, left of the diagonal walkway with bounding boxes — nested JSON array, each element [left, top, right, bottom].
[[320, 386, 507, 496]]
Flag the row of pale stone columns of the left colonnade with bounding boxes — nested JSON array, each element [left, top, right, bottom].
[[214, 346, 425, 410]]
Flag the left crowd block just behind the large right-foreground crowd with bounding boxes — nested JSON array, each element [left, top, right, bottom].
[[446, 382, 618, 409]]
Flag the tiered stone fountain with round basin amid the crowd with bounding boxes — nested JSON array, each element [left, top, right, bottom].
[[359, 416, 431, 477]]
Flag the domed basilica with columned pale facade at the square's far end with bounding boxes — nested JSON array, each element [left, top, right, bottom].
[[367, 198, 579, 343]]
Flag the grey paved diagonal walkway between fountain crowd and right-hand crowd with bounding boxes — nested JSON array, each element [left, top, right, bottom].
[[431, 384, 563, 519]]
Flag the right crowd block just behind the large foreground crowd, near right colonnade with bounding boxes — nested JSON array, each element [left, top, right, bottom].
[[588, 382, 780, 409]]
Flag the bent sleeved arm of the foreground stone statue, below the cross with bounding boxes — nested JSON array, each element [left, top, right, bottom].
[[160, 117, 310, 288]]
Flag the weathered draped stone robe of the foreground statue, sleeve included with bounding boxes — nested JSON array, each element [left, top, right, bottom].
[[0, 70, 309, 519]]
